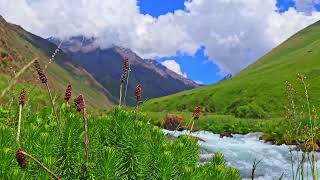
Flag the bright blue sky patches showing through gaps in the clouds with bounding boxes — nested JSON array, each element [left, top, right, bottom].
[[138, 0, 320, 84]]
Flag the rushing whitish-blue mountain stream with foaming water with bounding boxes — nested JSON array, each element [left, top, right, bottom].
[[163, 130, 320, 180]]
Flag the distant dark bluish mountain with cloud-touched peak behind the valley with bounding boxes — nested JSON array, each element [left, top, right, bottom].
[[49, 36, 199, 105]]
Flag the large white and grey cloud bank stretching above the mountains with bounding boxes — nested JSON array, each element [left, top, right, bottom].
[[0, 0, 320, 74]]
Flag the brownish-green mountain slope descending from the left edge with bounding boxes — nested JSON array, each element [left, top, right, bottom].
[[0, 16, 113, 108]]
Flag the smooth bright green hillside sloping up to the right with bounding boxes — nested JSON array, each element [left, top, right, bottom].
[[143, 22, 320, 117]]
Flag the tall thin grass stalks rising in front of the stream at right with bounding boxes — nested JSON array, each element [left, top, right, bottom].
[[284, 74, 320, 180]]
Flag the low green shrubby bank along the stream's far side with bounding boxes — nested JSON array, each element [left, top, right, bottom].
[[145, 112, 320, 145]]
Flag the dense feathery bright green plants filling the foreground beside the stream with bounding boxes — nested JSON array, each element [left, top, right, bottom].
[[0, 104, 240, 180]]
